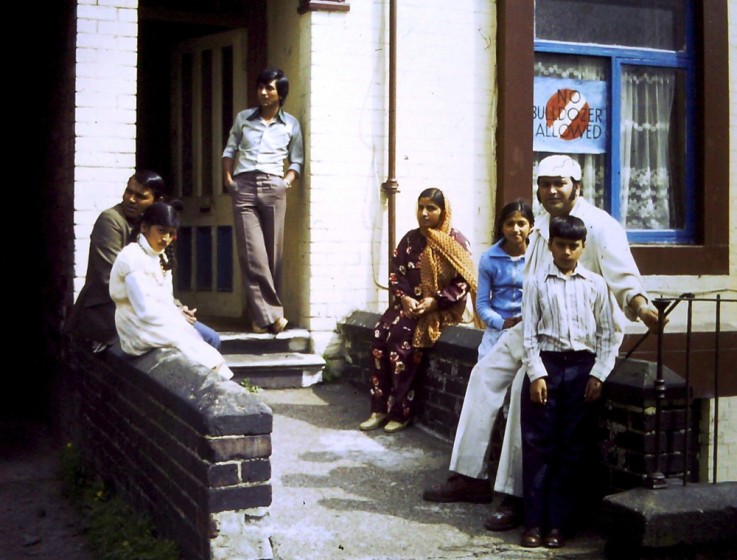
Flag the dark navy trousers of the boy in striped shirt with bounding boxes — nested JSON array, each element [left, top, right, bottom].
[[521, 352, 595, 531]]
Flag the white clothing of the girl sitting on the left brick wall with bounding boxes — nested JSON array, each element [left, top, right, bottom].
[[110, 235, 229, 371]]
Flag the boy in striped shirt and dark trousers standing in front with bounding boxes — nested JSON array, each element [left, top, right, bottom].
[[520, 215, 619, 548]]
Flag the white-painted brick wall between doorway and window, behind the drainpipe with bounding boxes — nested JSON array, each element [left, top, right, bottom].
[[301, 0, 496, 351]]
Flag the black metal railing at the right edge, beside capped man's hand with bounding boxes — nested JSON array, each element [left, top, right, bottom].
[[624, 293, 737, 488]]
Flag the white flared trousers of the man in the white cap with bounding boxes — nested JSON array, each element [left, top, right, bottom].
[[450, 323, 524, 482]]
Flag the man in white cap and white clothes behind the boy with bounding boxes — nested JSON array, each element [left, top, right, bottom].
[[422, 155, 658, 531]]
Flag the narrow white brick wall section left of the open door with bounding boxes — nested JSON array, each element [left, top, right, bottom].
[[74, 0, 138, 297]]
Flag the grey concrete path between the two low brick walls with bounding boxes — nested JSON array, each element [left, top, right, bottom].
[[260, 383, 604, 560]]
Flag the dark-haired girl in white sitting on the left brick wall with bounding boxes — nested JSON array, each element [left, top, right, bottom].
[[110, 201, 233, 379]]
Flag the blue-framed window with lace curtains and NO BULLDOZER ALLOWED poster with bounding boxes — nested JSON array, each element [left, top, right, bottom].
[[533, 0, 697, 244]]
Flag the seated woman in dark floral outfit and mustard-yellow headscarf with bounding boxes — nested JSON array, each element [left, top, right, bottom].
[[359, 188, 476, 433]]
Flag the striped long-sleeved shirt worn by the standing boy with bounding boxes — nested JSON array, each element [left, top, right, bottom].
[[522, 262, 619, 381]]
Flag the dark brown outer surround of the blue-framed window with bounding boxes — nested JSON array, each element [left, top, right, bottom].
[[496, 0, 730, 275]]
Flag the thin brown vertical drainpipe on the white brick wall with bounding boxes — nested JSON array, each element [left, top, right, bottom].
[[381, 0, 399, 282]]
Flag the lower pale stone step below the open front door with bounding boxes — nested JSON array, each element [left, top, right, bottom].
[[225, 350, 325, 389]]
